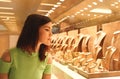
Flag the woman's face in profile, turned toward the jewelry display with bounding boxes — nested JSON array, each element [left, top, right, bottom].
[[39, 22, 52, 45]]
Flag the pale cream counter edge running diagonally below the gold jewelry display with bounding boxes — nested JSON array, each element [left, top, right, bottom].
[[53, 60, 86, 79]]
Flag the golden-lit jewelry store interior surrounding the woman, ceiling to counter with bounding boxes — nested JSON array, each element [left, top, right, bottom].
[[0, 0, 120, 79]]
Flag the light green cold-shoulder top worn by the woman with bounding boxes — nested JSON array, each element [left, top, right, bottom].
[[0, 48, 51, 79]]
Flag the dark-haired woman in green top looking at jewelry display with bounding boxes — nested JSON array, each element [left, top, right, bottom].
[[0, 14, 52, 79]]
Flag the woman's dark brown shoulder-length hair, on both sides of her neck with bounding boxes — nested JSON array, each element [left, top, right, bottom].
[[16, 14, 51, 60]]
